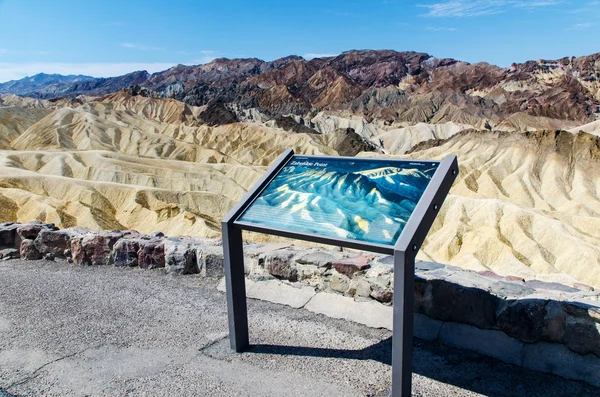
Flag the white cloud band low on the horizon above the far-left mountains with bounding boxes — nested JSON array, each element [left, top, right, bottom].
[[0, 62, 175, 82]]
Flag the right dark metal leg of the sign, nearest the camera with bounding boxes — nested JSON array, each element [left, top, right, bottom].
[[392, 250, 416, 397]]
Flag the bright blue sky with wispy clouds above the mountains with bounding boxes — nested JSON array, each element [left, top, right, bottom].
[[0, 0, 600, 82]]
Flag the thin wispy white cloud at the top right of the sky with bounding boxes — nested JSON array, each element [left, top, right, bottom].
[[418, 0, 563, 18]]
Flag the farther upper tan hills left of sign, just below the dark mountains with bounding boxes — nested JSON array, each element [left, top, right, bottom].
[[11, 98, 335, 165]]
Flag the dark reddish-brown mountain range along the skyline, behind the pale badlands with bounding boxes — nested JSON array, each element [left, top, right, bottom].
[[0, 50, 600, 130]]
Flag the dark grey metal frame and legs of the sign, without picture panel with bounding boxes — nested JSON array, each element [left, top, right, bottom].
[[221, 149, 458, 397]]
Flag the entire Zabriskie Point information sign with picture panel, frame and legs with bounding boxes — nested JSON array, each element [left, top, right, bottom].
[[222, 150, 458, 397]]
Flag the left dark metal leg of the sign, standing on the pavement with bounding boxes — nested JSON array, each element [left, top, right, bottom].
[[222, 222, 250, 353]]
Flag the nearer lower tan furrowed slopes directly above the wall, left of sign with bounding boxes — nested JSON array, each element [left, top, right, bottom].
[[0, 151, 264, 237]]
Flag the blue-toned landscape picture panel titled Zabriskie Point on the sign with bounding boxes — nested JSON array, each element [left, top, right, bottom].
[[239, 156, 439, 245]]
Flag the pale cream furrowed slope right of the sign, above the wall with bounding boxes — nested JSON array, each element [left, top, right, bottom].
[[410, 131, 600, 287]]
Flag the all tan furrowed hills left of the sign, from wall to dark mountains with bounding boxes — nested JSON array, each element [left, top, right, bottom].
[[0, 93, 337, 237]]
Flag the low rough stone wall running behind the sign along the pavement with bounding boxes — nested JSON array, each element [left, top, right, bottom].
[[0, 222, 600, 386]]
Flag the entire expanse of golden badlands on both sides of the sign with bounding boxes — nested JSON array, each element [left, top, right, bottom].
[[0, 92, 600, 287]]
